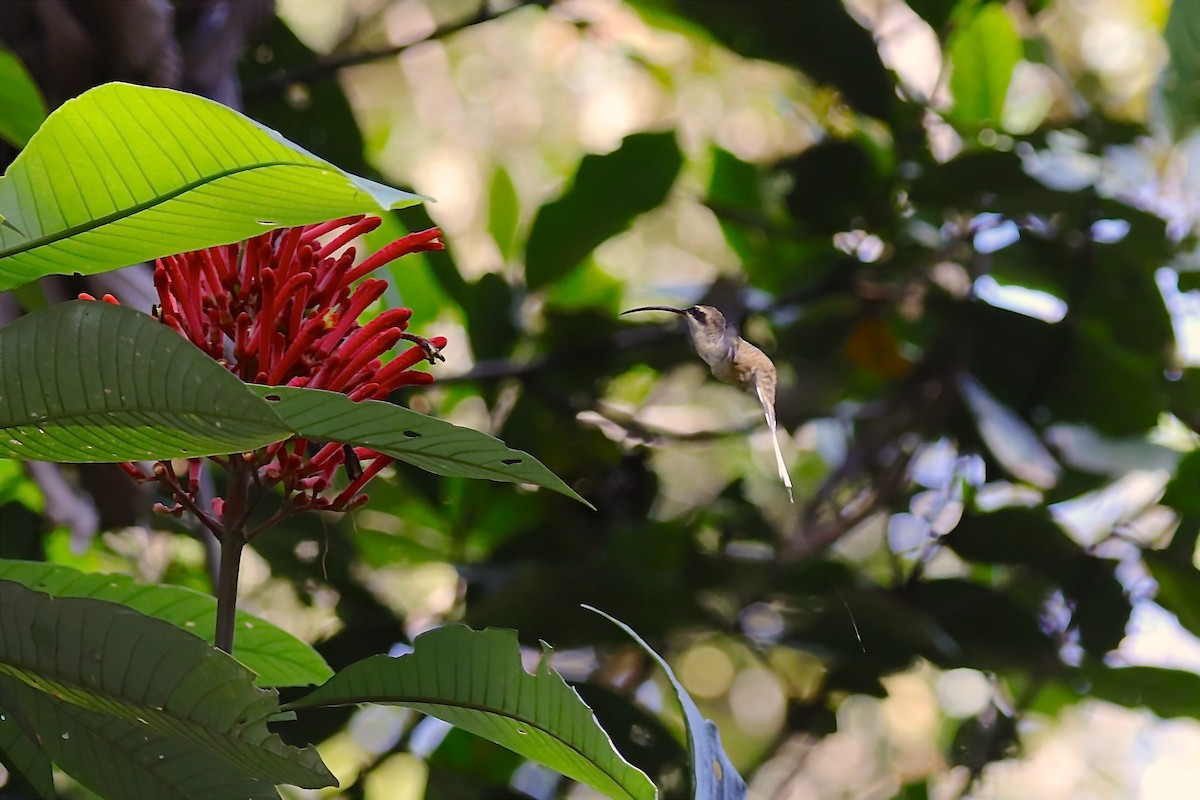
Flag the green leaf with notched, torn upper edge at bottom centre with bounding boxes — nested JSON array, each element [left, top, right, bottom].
[[284, 625, 656, 799]]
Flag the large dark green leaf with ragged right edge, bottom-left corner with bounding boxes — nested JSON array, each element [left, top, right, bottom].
[[0, 581, 336, 800]]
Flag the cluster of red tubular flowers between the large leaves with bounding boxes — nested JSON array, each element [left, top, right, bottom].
[[94, 216, 446, 527]]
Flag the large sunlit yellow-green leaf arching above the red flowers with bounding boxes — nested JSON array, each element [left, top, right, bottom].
[[0, 84, 420, 289]]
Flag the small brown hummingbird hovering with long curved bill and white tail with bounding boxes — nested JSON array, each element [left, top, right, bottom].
[[620, 306, 796, 504]]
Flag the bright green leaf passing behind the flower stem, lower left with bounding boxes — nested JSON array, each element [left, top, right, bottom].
[[0, 560, 334, 686]]
